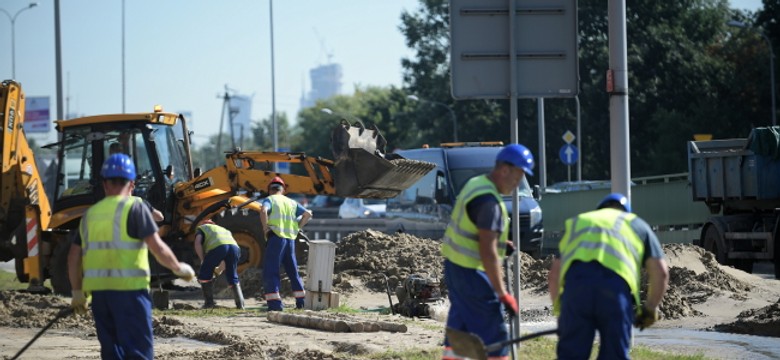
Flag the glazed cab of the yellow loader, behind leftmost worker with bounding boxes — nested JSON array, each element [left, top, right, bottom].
[[53, 113, 192, 226]]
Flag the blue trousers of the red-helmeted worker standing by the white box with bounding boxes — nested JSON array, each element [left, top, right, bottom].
[[263, 234, 303, 310]]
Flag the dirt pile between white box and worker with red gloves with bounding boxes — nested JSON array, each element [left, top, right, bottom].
[[334, 229, 444, 292]]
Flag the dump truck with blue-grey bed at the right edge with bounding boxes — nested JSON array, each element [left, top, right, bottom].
[[688, 127, 780, 279]]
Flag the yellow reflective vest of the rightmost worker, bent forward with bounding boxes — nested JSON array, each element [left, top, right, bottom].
[[553, 208, 645, 315]]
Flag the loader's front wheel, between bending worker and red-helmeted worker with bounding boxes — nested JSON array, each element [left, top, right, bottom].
[[214, 211, 265, 274]]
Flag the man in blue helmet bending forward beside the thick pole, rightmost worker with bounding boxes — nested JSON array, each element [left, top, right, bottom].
[[548, 193, 669, 359]]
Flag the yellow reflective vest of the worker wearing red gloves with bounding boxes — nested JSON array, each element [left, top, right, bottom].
[[441, 175, 509, 271]]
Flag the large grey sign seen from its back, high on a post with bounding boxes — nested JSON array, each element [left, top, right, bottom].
[[450, 0, 579, 99]]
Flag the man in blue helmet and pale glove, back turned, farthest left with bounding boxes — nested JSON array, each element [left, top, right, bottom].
[[68, 154, 195, 359]]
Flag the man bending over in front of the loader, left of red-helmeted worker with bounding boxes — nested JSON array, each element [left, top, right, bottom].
[[195, 219, 244, 309]]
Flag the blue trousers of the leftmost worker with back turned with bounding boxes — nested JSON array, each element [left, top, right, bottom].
[[92, 289, 154, 360]]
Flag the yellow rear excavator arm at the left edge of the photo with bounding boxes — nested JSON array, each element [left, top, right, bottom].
[[0, 80, 51, 284]]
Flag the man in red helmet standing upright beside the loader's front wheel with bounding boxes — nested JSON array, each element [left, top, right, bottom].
[[260, 176, 311, 311]]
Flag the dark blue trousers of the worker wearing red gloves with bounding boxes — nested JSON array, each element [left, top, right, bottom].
[[444, 260, 509, 357]]
